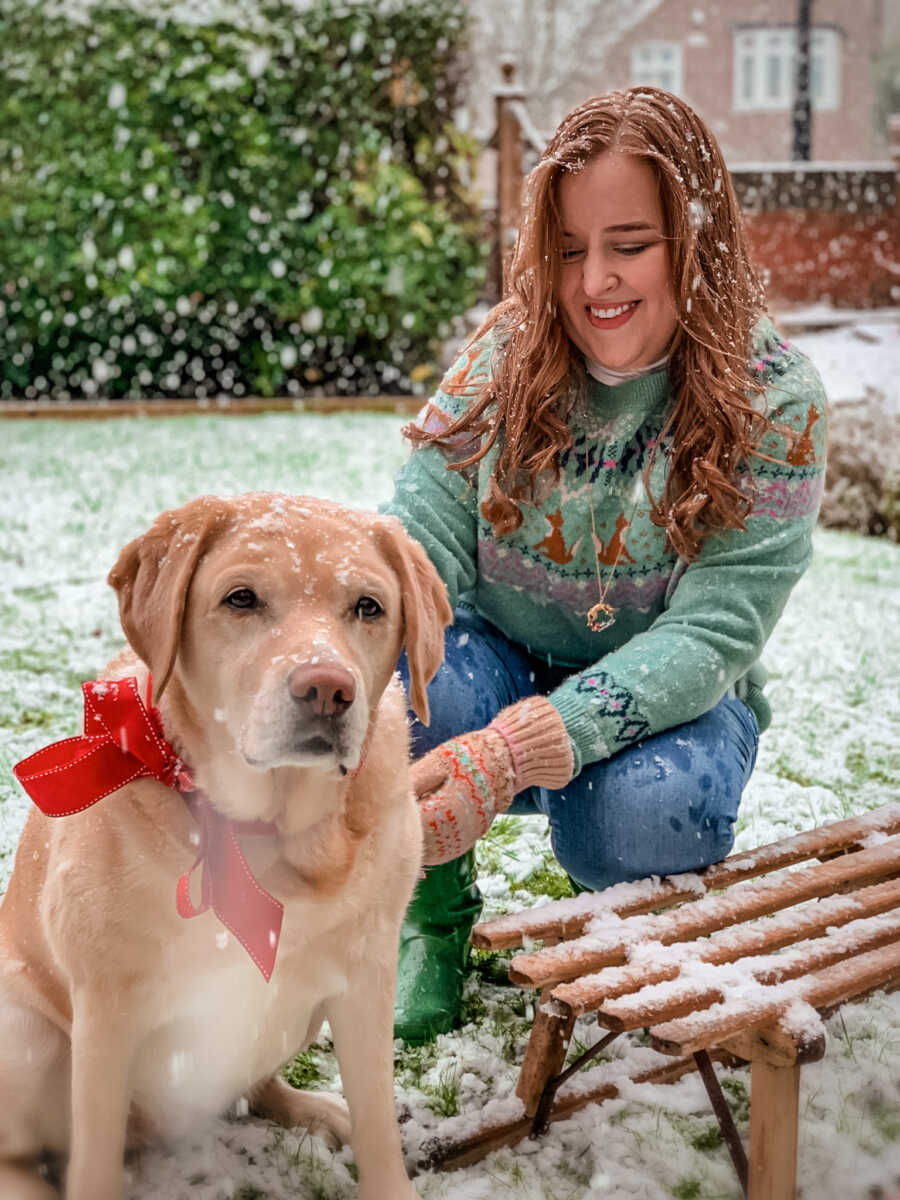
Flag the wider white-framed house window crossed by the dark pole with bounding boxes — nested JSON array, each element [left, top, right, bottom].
[[733, 25, 841, 113]]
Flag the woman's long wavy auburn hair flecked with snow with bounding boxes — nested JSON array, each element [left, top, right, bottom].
[[404, 88, 787, 562]]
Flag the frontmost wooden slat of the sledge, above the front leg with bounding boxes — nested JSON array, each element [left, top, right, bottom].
[[650, 942, 900, 1055]]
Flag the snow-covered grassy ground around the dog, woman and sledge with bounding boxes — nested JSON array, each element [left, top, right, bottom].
[[0, 322, 900, 1200]]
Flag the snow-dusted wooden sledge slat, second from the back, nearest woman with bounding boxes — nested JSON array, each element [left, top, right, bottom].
[[509, 838, 900, 988]]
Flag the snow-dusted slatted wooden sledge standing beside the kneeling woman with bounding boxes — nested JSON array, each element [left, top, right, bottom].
[[422, 803, 900, 1200]]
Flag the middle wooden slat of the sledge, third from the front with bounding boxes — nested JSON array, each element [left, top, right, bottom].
[[552, 880, 900, 1015]]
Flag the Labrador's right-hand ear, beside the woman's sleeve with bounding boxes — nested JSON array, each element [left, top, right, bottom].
[[378, 517, 454, 725]]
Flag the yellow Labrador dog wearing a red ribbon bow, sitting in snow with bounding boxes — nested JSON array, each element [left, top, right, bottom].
[[0, 493, 451, 1200]]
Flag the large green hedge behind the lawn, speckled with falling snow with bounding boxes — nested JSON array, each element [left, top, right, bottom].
[[0, 0, 484, 397]]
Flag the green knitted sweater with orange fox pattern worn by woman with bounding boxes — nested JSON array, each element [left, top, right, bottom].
[[385, 320, 826, 773]]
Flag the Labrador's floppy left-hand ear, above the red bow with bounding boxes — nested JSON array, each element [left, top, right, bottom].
[[107, 496, 230, 701]]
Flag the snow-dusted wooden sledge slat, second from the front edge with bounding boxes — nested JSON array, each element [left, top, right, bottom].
[[588, 912, 900, 1033]]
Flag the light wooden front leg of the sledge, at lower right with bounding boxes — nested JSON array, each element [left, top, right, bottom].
[[748, 1055, 800, 1200]]
